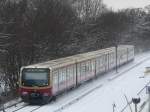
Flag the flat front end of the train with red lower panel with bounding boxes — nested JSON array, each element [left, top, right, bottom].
[[19, 68, 52, 103]]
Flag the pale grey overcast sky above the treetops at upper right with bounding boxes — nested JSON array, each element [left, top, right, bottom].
[[103, 0, 150, 10]]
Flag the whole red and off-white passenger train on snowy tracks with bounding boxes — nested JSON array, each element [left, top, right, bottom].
[[19, 45, 134, 103]]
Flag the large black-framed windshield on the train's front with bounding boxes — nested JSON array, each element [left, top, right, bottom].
[[22, 68, 50, 87]]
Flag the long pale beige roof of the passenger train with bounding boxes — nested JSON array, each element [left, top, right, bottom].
[[22, 45, 134, 69]]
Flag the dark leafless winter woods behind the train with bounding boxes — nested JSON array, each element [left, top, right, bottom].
[[0, 0, 150, 100]]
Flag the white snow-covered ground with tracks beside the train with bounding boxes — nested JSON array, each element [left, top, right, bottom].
[[2, 53, 150, 112]]
